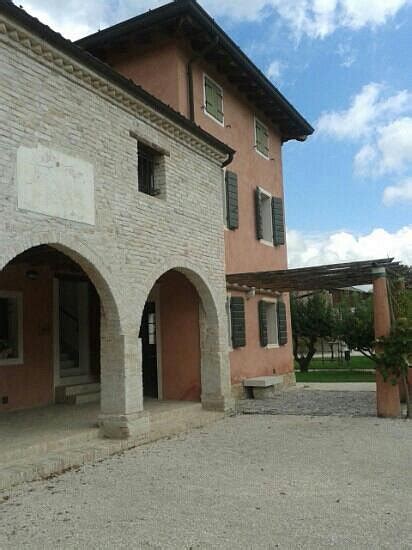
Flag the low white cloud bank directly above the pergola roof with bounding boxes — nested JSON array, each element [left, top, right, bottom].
[[288, 225, 412, 267]]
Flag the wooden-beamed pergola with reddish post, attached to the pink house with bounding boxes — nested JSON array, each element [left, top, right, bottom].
[[226, 258, 412, 417]]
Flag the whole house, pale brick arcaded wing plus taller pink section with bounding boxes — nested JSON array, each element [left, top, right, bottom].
[[0, 0, 312, 437]]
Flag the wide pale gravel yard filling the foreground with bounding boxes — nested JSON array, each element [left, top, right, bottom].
[[0, 415, 412, 550]]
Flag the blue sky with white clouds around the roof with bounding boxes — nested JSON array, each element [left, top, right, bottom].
[[16, 0, 412, 267]]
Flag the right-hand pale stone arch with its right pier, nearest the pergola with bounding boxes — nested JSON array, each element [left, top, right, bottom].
[[138, 256, 230, 410]]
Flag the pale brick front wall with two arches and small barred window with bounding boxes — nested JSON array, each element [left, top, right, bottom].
[[0, 15, 230, 436]]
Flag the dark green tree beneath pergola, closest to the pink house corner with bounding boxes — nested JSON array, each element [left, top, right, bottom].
[[291, 292, 336, 372]]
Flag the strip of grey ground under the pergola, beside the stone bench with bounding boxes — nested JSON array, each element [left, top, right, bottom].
[[238, 389, 376, 416]]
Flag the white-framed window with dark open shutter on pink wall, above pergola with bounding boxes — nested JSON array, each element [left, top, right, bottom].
[[255, 187, 285, 246]]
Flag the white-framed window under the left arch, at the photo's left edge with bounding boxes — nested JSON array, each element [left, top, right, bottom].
[[0, 292, 23, 365]]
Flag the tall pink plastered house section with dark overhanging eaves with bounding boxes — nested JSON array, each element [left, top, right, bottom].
[[78, 0, 313, 397]]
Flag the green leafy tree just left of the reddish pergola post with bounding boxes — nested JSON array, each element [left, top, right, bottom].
[[336, 296, 377, 362]]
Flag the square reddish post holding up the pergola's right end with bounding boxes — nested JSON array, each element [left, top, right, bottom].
[[372, 267, 401, 418]]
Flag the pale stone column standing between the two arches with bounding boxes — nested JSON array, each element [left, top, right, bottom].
[[99, 326, 149, 440]]
